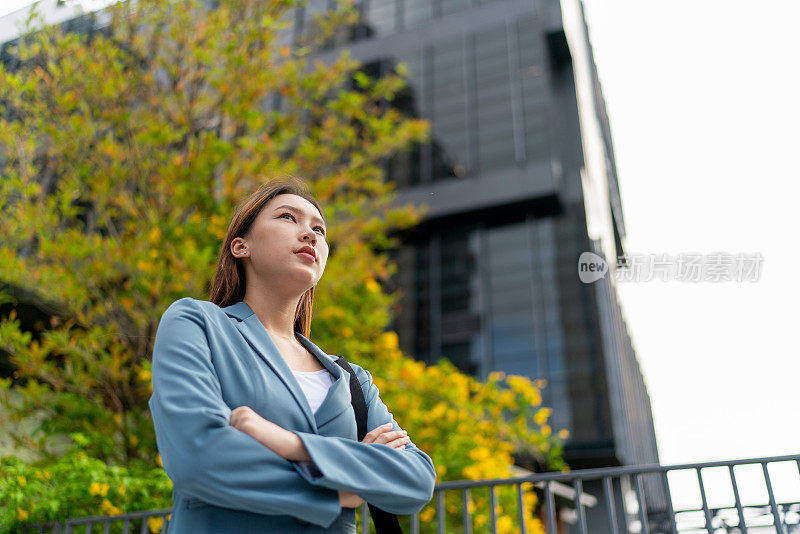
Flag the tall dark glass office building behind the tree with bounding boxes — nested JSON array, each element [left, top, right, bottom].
[[294, 0, 666, 522]]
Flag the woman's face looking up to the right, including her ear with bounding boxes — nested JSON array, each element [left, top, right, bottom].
[[231, 194, 328, 294]]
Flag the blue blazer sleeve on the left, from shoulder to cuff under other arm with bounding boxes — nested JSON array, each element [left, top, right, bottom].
[[149, 297, 342, 527]]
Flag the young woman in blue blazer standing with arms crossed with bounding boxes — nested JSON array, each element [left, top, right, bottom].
[[150, 180, 436, 534]]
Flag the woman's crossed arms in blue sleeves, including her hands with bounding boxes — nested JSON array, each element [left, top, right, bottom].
[[149, 298, 436, 527]]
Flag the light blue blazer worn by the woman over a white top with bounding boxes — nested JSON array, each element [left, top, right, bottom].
[[149, 297, 436, 534]]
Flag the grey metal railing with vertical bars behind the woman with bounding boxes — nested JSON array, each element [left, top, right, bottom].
[[23, 455, 800, 534]]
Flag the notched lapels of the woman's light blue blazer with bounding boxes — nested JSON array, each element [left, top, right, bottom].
[[222, 301, 351, 434]]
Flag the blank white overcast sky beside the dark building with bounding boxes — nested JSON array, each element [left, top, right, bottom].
[[0, 0, 800, 508]]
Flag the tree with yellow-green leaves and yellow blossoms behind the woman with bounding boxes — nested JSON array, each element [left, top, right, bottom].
[[0, 0, 563, 528]]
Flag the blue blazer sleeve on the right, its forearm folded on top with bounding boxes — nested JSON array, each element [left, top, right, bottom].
[[292, 364, 436, 515]]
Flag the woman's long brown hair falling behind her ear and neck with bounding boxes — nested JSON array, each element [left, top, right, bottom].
[[209, 179, 325, 338]]
